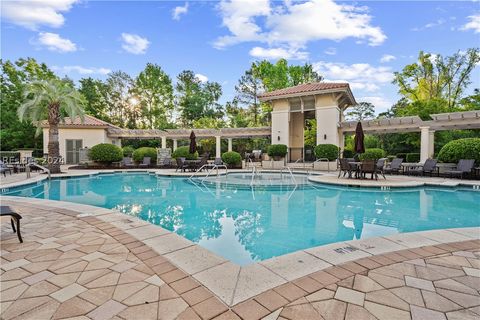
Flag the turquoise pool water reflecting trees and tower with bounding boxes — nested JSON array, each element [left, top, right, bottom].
[[3, 173, 480, 265]]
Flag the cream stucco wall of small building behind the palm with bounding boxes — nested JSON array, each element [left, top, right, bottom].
[[43, 128, 111, 160]]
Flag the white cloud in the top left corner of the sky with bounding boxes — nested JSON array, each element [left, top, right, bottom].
[[1, 0, 79, 30]]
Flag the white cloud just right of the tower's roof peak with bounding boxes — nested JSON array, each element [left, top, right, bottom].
[[313, 61, 393, 87]]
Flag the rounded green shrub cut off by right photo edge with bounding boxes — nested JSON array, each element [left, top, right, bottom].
[[438, 138, 480, 164]]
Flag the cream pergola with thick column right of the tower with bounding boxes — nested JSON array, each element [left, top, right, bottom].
[[340, 110, 480, 162]]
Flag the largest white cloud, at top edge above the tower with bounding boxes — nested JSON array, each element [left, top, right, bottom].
[[215, 0, 387, 48]]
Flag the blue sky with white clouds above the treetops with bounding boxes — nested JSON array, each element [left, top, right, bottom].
[[1, 0, 480, 112]]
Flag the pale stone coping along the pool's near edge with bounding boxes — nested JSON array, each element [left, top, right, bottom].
[[0, 192, 480, 306]]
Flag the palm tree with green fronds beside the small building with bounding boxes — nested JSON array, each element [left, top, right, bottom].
[[17, 79, 85, 173]]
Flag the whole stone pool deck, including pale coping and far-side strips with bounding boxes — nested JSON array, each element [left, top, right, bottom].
[[0, 170, 480, 320]]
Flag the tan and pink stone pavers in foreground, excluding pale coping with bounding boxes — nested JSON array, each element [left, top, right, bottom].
[[0, 201, 480, 320]]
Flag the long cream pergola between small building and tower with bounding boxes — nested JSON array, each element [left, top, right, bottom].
[[108, 127, 271, 157]]
